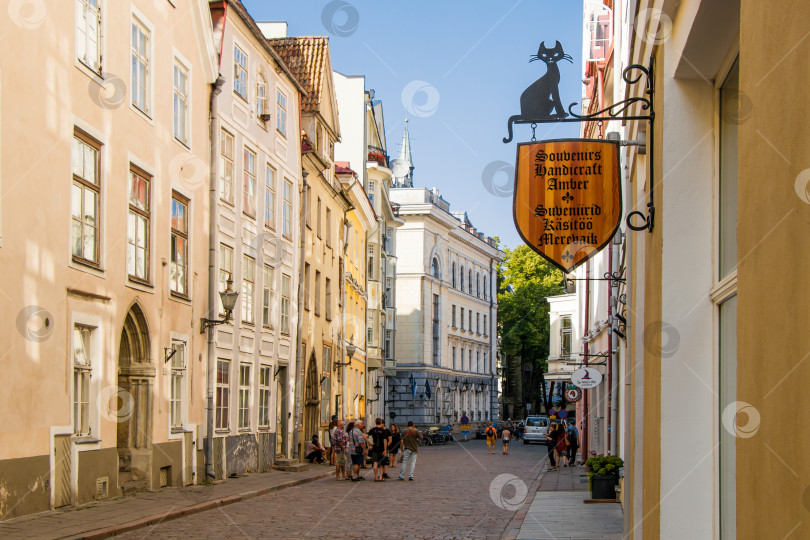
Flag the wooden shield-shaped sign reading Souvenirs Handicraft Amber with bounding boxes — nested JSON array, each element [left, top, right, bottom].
[[513, 139, 622, 273]]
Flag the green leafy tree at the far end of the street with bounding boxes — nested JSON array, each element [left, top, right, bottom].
[[498, 245, 563, 416]]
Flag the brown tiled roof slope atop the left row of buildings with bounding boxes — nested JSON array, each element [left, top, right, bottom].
[[267, 36, 331, 112]]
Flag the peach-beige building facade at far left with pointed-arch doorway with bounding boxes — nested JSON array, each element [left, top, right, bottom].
[[0, 0, 216, 518]]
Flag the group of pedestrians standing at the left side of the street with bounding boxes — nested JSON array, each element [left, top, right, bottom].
[[329, 417, 422, 482]]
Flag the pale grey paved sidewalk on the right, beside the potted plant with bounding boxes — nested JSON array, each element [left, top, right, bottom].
[[505, 466, 624, 540]]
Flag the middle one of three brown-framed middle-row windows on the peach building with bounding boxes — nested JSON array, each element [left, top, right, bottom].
[[127, 169, 151, 283]]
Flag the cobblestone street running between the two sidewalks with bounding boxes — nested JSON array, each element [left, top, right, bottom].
[[118, 441, 546, 538]]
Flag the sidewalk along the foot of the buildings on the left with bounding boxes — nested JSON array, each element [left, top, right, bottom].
[[0, 465, 335, 539]]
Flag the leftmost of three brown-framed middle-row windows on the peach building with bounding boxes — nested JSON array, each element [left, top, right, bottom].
[[70, 134, 101, 266]]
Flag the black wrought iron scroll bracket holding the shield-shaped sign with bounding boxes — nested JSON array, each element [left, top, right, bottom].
[[503, 56, 655, 233]]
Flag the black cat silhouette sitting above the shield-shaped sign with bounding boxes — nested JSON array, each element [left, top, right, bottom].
[[520, 41, 574, 119]]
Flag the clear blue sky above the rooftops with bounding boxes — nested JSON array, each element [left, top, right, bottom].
[[243, 0, 583, 248]]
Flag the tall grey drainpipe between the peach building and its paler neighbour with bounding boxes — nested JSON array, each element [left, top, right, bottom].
[[205, 75, 225, 478]]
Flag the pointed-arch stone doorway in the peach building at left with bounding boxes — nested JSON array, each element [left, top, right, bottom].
[[117, 303, 155, 489]]
